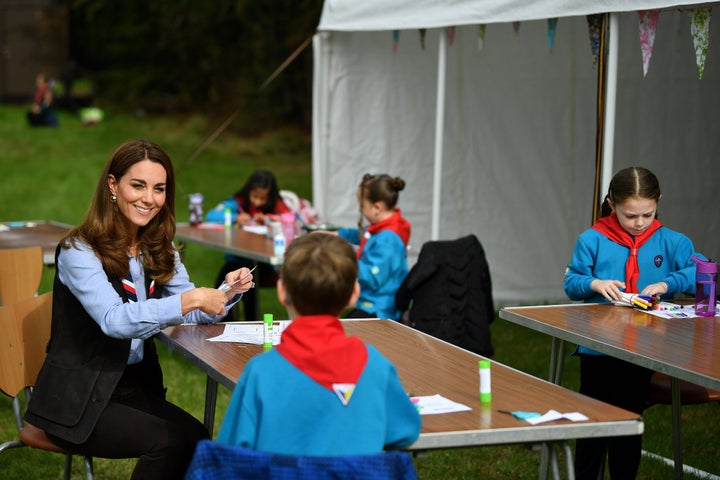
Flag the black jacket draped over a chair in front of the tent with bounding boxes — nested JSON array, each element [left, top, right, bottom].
[[395, 235, 495, 357]]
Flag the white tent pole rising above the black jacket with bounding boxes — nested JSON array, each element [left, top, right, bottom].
[[430, 29, 447, 240]]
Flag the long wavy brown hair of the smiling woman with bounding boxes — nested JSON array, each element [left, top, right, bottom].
[[62, 140, 175, 283]]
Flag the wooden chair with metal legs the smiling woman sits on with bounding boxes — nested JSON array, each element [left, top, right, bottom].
[[0, 292, 93, 480]]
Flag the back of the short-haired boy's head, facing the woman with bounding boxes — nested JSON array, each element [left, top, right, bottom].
[[281, 233, 358, 316]]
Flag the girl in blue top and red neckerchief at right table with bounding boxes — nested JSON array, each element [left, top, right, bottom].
[[564, 167, 705, 479]]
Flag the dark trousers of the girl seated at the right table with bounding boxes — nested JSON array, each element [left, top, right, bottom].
[[575, 354, 653, 480]]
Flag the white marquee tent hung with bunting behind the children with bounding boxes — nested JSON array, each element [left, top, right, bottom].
[[313, 0, 720, 305]]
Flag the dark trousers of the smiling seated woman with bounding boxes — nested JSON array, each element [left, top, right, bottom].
[[48, 370, 210, 480]]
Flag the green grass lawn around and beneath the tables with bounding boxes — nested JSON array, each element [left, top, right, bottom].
[[0, 105, 720, 480]]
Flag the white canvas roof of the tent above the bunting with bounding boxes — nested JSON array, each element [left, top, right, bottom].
[[318, 0, 707, 31]]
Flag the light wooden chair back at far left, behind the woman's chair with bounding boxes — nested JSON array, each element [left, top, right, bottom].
[[0, 247, 43, 305]]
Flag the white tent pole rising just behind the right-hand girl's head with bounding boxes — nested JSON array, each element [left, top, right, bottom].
[[598, 12, 620, 217]]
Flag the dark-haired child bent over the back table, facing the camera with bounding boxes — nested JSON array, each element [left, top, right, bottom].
[[205, 170, 290, 321]]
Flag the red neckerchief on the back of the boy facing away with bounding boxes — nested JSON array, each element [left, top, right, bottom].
[[277, 315, 368, 391]]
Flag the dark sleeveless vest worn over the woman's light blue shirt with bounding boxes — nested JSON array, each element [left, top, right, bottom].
[[25, 246, 165, 444]]
